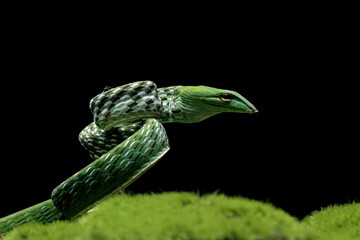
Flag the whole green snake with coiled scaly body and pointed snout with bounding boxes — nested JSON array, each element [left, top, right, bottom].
[[0, 81, 257, 234]]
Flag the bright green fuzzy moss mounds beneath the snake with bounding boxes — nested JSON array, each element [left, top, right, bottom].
[[3, 193, 360, 240]]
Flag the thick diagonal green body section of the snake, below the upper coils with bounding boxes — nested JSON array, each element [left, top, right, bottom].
[[51, 119, 169, 218]]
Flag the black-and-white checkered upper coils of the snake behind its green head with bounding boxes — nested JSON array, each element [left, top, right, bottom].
[[79, 81, 185, 159]]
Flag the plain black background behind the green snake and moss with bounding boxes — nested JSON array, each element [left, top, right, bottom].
[[0, 1, 360, 218]]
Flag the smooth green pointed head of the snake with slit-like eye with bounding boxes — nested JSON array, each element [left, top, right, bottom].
[[181, 86, 258, 121]]
